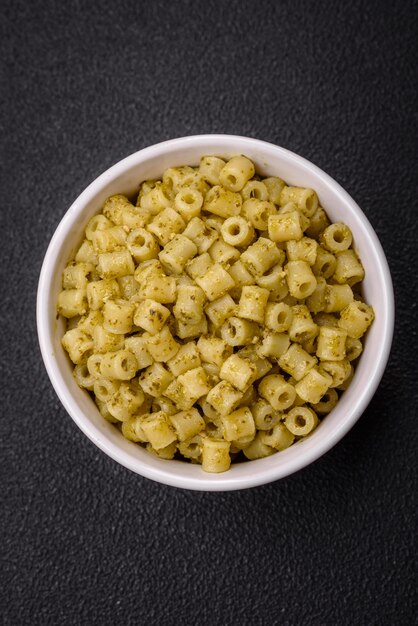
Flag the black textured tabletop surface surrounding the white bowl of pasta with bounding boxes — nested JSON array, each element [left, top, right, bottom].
[[0, 0, 418, 626]]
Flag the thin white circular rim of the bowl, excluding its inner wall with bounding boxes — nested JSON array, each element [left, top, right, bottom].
[[36, 134, 395, 491]]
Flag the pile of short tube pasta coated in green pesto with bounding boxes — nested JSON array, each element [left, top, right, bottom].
[[58, 156, 374, 472]]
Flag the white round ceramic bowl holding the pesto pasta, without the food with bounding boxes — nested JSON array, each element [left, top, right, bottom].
[[37, 135, 394, 491]]
